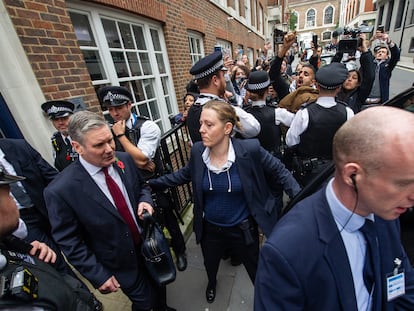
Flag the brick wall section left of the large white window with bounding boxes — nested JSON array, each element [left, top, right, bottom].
[[5, 0, 99, 111]]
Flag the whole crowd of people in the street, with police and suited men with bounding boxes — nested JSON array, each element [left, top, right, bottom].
[[0, 26, 414, 311]]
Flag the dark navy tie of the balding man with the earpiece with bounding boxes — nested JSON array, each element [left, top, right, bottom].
[[359, 219, 382, 311]]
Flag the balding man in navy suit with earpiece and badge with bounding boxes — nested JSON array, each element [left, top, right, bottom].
[[254, 107, 414, 311]]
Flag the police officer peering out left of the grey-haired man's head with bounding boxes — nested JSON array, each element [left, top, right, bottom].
[[41, 100, 78, 171]]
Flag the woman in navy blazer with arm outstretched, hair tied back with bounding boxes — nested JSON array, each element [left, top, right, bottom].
[[149, 100, 300, 303]]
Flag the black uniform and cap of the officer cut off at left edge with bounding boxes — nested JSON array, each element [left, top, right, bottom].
[[0, 169, 94, 311]]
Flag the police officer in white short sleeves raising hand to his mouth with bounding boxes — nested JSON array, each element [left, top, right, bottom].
[[98, 86, 187, 271]]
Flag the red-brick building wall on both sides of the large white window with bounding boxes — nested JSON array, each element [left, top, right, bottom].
[[4, 0, 267, 111]]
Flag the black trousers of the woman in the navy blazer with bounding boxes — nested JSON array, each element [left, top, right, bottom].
[[201, 220, 259, 287]]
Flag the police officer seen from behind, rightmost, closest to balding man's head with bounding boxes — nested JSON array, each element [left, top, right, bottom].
[[286, 63, 354, 186]]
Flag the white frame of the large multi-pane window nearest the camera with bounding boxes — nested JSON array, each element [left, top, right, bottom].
[[67, 3, 178, 132]]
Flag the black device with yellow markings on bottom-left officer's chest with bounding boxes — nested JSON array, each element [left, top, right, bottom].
[[0, 266, 39, 301]]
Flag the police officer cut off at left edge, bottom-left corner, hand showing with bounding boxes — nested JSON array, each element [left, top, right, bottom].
[[0, 167, 97, 311]]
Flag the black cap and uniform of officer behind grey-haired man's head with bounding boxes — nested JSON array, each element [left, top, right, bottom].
[[41, 100, 79, 171]]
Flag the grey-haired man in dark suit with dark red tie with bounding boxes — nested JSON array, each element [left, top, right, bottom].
[[44, 111, 174, 310]]
